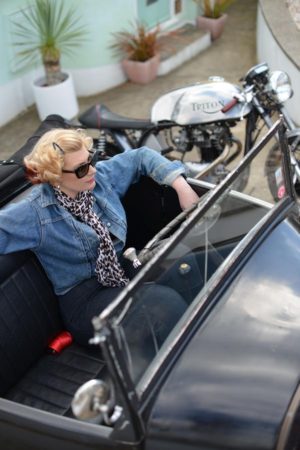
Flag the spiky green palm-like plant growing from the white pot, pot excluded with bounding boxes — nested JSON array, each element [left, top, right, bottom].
[[13, 0, 87, 85]]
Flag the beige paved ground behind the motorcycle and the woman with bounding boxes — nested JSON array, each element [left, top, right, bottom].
[[0, 0, 257, 159]]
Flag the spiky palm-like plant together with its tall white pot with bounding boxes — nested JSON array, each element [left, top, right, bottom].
[[13, 0, 86, 120]]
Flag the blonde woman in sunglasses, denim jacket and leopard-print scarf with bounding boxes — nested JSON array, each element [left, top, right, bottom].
[[0, 129, 198, 344]]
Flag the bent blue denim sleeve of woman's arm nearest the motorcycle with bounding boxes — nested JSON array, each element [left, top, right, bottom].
[[96, 147, 185, 196]]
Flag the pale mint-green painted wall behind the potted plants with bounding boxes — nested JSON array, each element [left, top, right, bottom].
[[0, 0, 197, 86]]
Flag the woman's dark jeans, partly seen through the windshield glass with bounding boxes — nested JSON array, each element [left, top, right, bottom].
[[59, 278, 187, 378]]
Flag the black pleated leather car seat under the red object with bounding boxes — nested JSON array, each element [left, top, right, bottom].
[[0, 251, 105, 415]]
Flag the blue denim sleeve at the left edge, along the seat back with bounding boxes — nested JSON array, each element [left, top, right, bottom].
[[0, 200, 41, 254]]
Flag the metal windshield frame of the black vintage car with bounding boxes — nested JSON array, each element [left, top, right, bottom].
[[89, 119, 296, 433]]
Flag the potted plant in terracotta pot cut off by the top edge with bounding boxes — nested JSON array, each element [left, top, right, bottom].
[[194, 0, 235, 40]]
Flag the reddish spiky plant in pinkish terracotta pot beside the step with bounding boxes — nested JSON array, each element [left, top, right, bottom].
[[110, 23, 162, 84]]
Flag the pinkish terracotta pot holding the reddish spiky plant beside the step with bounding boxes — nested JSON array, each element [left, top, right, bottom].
[[122, 54, 159, 84]]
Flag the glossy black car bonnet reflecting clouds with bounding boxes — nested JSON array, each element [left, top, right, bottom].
[[147, 217, 300, 450]]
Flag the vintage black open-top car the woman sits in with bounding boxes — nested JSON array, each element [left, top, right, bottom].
[[0, 116, 300, 450]]
